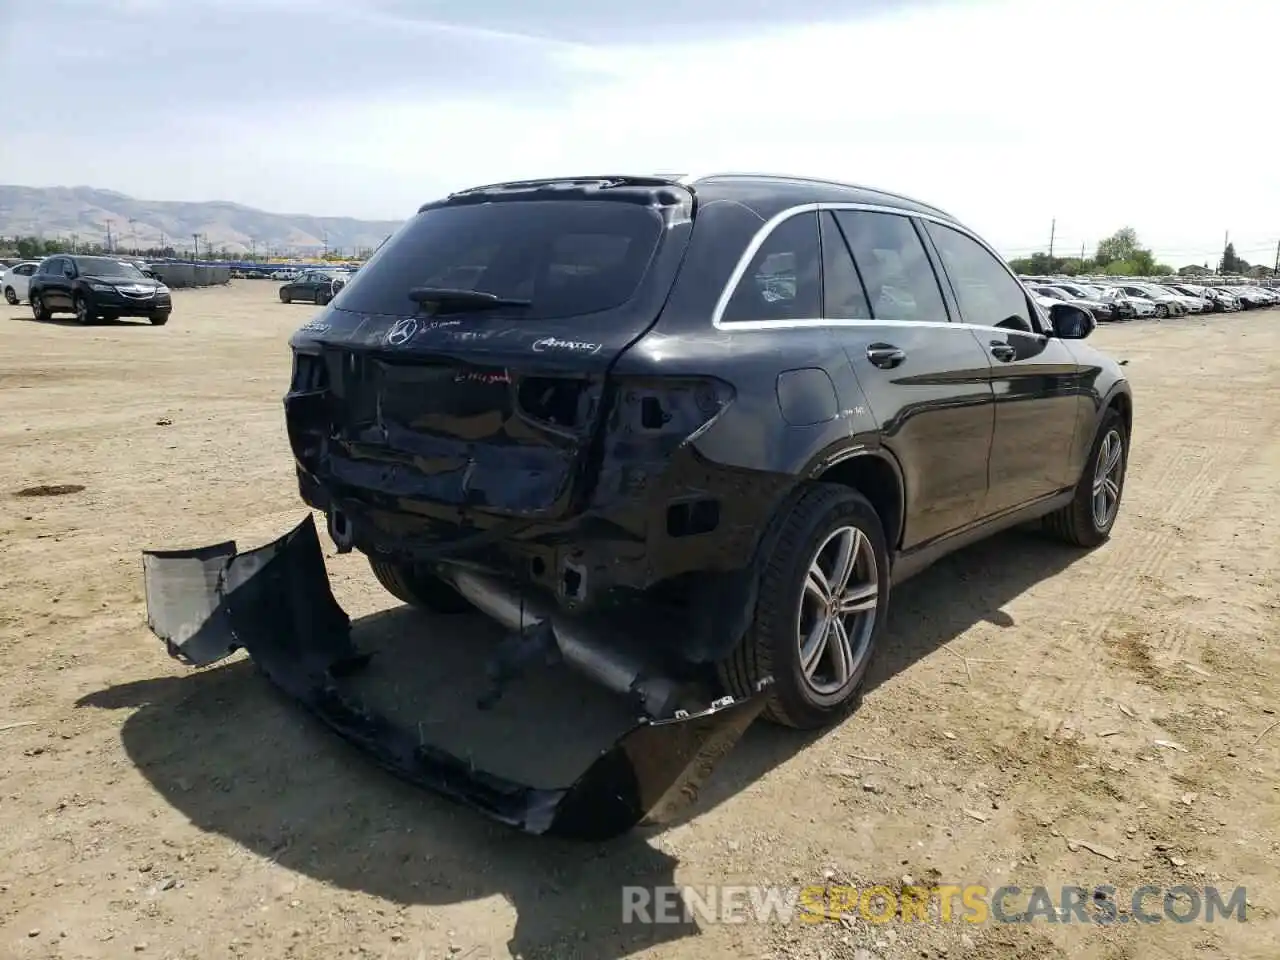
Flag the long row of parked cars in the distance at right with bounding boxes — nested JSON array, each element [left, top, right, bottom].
[[1021, 276, 1280, 321]]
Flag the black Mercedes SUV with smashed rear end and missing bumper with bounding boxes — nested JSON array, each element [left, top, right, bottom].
[[285, 174, 1132, 727]]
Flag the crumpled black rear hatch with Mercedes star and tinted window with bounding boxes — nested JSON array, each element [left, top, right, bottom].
[[287, 178, 692, 520]]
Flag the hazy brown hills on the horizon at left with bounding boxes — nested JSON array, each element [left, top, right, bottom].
[[0, 186, 399, 255]]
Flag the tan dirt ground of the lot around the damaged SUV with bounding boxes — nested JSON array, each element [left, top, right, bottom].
[[0, 282, 1280, 960]]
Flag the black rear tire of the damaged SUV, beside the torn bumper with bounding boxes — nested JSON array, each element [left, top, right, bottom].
[[717, 484, 890, 730]]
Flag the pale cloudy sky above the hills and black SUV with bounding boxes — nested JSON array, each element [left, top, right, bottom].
[[0, 0, 1280, 266]]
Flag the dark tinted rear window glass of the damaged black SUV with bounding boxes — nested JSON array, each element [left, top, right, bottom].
[[334, 200, 663, 320]]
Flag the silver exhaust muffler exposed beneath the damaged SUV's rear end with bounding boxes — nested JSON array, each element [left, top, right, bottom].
[[440, 567, 680, 719]]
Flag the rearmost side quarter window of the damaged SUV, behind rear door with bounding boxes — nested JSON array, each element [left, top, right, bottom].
[[722, 214, 822, 323]]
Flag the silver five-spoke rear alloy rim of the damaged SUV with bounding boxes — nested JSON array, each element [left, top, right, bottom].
[[796, 526, 879, 699]]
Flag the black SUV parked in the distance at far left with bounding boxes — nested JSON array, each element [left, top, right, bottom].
[[27, 253, 173, 326]]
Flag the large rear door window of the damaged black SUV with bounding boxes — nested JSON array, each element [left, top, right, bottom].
[[836, 210, 947, 323]]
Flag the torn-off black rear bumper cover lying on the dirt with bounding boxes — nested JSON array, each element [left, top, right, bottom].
[[143, 515, 764, 841]]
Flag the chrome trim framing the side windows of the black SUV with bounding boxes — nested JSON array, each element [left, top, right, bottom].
[[712, 201, 1047, 338]]
